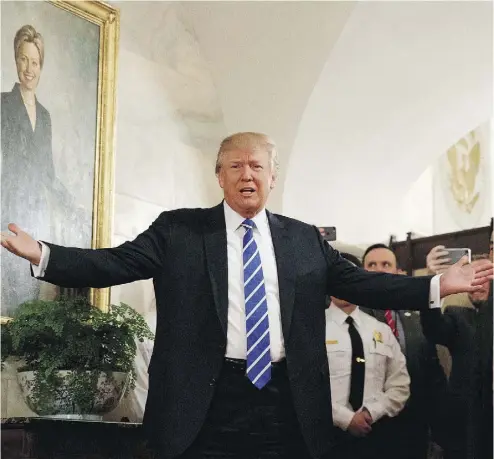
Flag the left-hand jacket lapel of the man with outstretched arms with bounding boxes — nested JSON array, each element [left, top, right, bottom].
[[204, 203, 228, 336]]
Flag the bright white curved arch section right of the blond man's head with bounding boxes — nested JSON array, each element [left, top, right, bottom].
[[283, 2, 493, 243]]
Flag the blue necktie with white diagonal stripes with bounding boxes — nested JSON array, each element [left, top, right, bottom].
[[242, 219, 271, 389]]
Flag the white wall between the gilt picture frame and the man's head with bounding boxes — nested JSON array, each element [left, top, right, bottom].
[[112, 2, 226, 312]]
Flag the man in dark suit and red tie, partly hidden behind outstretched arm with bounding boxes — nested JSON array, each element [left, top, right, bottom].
[[362, 244, 447, 459]]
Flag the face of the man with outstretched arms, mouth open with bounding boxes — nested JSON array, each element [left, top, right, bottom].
[[218, 149, 274, 218]]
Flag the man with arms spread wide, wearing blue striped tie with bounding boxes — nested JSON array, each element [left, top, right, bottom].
[[2, 133, 494, 459]]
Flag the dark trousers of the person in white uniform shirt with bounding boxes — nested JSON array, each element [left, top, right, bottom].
[[334, 417, 400, 459]]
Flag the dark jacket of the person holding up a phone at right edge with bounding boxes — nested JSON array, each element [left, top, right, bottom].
[[421, 300, 493, 459]]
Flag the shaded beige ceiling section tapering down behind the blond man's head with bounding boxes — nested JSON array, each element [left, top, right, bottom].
[[181, 2, 355, 211]]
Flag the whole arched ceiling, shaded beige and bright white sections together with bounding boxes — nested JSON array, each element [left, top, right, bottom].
[[115, 1, 492, 243]]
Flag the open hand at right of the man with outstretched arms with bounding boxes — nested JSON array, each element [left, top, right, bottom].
[[440, 257, 494, 298]]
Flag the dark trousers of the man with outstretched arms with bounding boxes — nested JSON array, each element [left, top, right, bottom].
[[180, 359, 309, 459]]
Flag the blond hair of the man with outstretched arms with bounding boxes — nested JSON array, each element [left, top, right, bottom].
[[215, 132, 280, 177]]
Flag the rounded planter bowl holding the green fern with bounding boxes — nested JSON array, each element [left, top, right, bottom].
[[17, 370, 129, 420]]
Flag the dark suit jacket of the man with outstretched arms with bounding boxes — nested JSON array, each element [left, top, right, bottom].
[[44, 205, 430, 457]]
